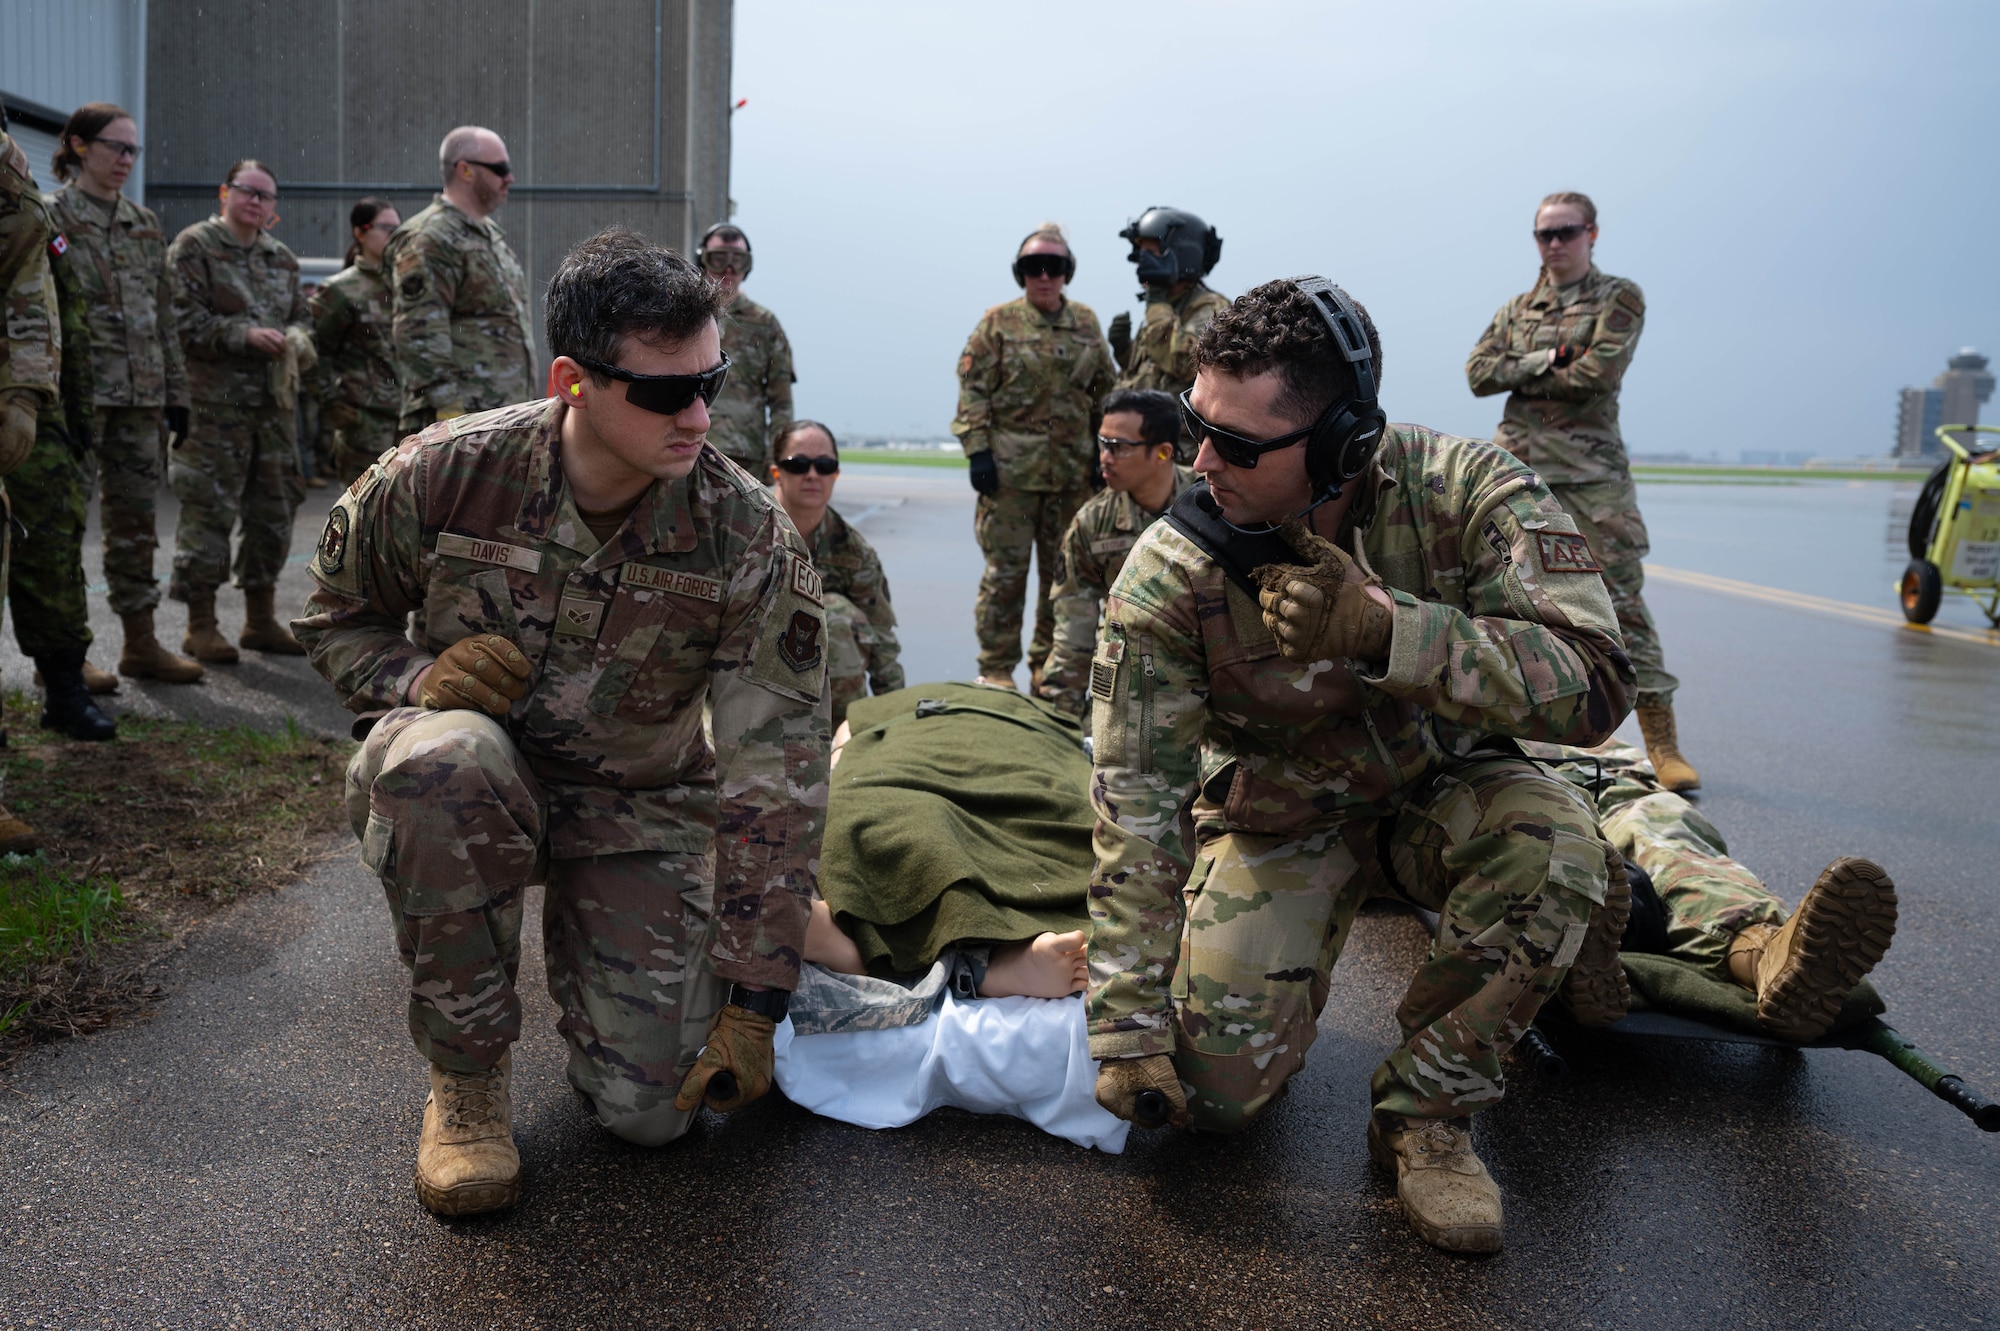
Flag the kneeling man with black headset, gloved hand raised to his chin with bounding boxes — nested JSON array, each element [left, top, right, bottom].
[[1088, 278, 1632, 1251]]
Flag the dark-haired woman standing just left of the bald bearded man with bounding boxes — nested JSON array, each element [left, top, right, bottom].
[[310, 198, 402, 486]]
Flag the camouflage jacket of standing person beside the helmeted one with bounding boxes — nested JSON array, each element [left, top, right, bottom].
[[952, 296, 1116, 492]]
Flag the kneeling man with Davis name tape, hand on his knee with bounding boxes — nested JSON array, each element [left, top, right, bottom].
[[296, 230, 828, 1215]]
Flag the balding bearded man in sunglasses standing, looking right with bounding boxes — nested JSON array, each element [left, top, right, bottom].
[[382, 124, 540, 432]]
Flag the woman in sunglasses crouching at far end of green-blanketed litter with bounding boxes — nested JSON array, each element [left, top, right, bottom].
[[764, 417, 902, 727]]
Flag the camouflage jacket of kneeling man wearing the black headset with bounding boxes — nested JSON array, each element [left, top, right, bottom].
[[1088, 426, 1632, 1057]]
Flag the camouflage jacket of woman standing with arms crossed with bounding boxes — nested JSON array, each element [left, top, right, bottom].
[[1466, 264, 1646, 486]]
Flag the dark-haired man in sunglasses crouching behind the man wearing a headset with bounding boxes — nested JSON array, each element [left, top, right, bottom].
[[1040, 388, 1194, 711]]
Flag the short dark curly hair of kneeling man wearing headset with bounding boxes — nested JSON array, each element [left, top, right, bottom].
[[1194, 278, 1382, 430]]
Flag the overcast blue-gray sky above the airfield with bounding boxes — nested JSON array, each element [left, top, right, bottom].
[[732, 0, 2000, 460]]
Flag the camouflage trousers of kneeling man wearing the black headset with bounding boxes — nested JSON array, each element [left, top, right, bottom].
[[1170, 757, 1604, 1133]]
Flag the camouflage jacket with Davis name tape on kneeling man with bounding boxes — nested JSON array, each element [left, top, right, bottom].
[[294, 402, 828, 989]]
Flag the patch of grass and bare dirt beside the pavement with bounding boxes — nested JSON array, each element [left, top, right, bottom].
[[0, 697, 352, 1067]]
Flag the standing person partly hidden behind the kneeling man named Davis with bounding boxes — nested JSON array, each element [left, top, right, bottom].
[[700, 222, 798, 478]]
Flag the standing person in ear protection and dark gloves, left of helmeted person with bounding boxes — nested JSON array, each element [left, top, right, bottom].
[[952, 222, 1116, 687]]
